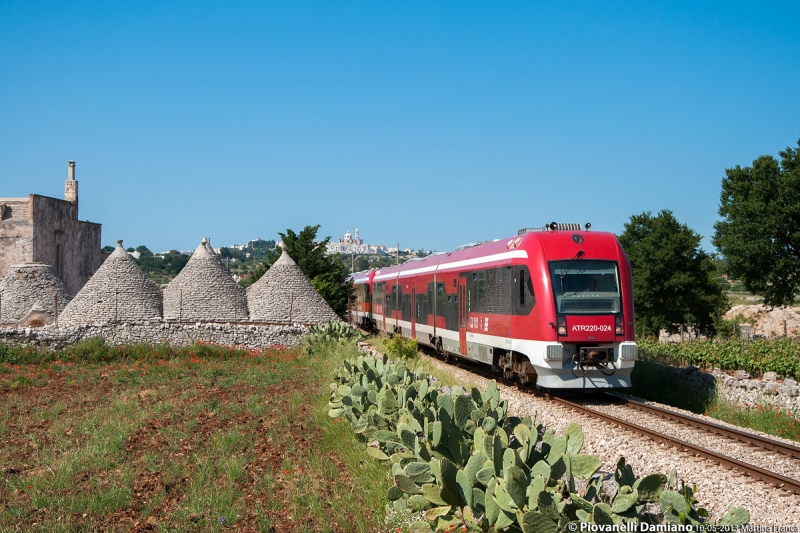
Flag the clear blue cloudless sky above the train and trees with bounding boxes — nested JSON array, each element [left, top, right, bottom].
[[0, 0, 800, 251]]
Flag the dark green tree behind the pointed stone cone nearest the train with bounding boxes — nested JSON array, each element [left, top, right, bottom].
[[241, 225, 353, 317]]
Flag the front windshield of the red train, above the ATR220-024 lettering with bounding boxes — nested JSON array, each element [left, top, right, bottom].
[[550, 259, 622, 315]]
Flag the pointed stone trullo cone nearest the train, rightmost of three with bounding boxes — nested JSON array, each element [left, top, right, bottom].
[[247, 250, 338, 324]]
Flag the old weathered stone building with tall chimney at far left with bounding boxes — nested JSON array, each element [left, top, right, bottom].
[[0, 161, 103, 295]]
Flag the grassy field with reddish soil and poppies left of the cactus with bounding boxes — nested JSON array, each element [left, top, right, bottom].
[[0, 340, 390, 532]]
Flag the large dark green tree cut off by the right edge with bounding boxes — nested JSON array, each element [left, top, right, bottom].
[[712, 140, 800, 306]]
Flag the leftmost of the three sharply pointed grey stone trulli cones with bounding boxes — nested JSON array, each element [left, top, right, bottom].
[[59, 241, 162, 325]]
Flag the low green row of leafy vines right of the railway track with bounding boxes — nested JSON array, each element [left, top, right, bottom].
[[637, 337, 800, 380]]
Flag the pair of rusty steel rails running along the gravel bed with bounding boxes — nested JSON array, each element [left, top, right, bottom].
[[412, 344, 800, 495]]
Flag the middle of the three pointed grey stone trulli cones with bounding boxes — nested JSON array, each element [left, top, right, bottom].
[[164, 239, 247, 322]]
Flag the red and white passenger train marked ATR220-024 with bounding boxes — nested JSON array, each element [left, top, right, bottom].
[[350, 222, 638, 389]]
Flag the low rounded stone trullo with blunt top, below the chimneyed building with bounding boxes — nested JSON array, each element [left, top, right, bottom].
[[0, 263, 72, 324]]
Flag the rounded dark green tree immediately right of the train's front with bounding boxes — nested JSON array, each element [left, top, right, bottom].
[[619, 210, 729, 335]]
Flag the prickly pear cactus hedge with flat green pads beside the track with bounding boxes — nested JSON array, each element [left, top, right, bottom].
[[328, 356, 749, 533]]
